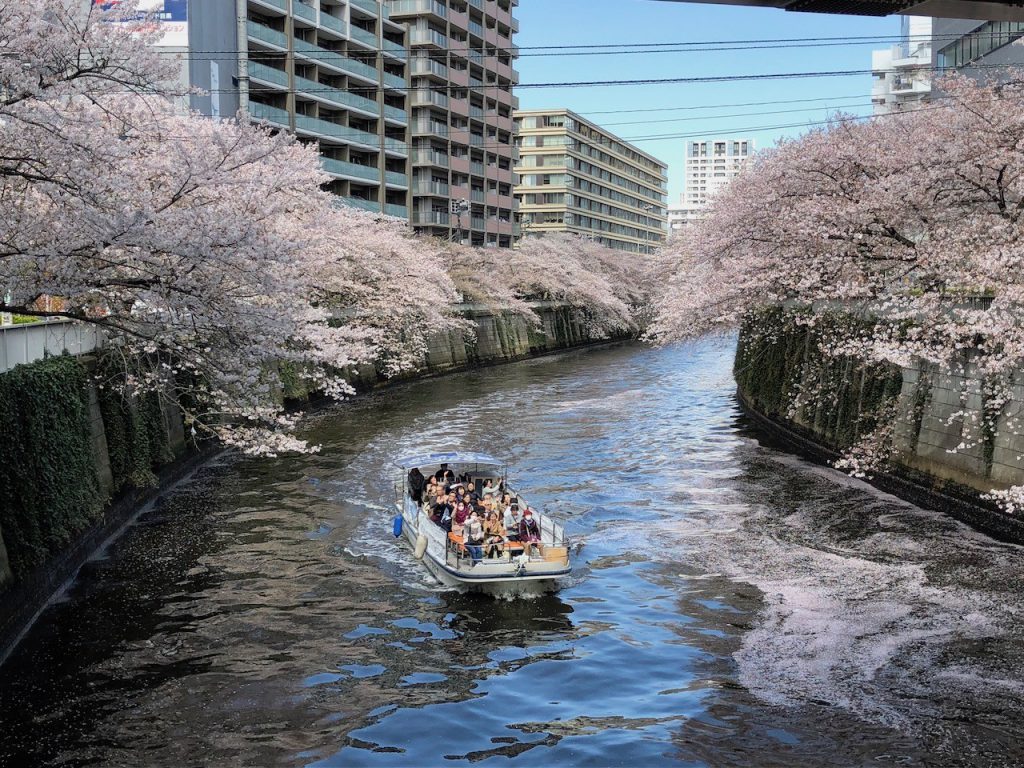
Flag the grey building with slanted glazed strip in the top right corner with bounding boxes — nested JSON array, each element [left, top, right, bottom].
[[932, 18, 1024, 79]]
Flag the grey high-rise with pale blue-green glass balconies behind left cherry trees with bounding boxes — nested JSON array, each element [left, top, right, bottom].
[[187, 0, 409, 218]]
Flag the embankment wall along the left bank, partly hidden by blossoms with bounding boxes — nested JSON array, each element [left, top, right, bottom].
[[0, 303, 614, 662]]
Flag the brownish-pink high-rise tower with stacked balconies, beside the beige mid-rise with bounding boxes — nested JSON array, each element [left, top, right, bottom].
[[388, 0, 518, 247]]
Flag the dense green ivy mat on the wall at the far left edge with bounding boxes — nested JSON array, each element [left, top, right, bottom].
[[0, 355, 102, 578]]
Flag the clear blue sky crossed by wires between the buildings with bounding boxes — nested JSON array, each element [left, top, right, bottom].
[[516, 0, 899, 205]]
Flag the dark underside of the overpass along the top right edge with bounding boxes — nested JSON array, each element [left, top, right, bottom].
[[659, 0, 1024, 22]]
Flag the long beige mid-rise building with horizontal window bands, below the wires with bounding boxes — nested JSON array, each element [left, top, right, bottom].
[[515, 110, 668, 253]]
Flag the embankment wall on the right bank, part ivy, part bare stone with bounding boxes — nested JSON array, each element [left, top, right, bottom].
[[734, 310, 1024, 543]]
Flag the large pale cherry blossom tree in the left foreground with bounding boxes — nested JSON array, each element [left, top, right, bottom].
[[0, 0, 458, 453]]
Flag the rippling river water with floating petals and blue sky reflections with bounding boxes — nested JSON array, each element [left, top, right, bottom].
[[0, 339, 1024, 768]]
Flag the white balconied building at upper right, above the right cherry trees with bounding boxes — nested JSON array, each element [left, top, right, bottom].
[[871, 16, 932, 115]]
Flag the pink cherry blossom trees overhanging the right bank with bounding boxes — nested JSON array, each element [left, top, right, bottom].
[[651, 72, 1024, 506]]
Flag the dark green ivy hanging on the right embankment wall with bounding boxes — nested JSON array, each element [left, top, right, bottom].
[[733, 307, 903, 450]]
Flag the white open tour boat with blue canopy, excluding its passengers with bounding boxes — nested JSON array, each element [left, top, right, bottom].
[[393, 452, 571, 597]]
